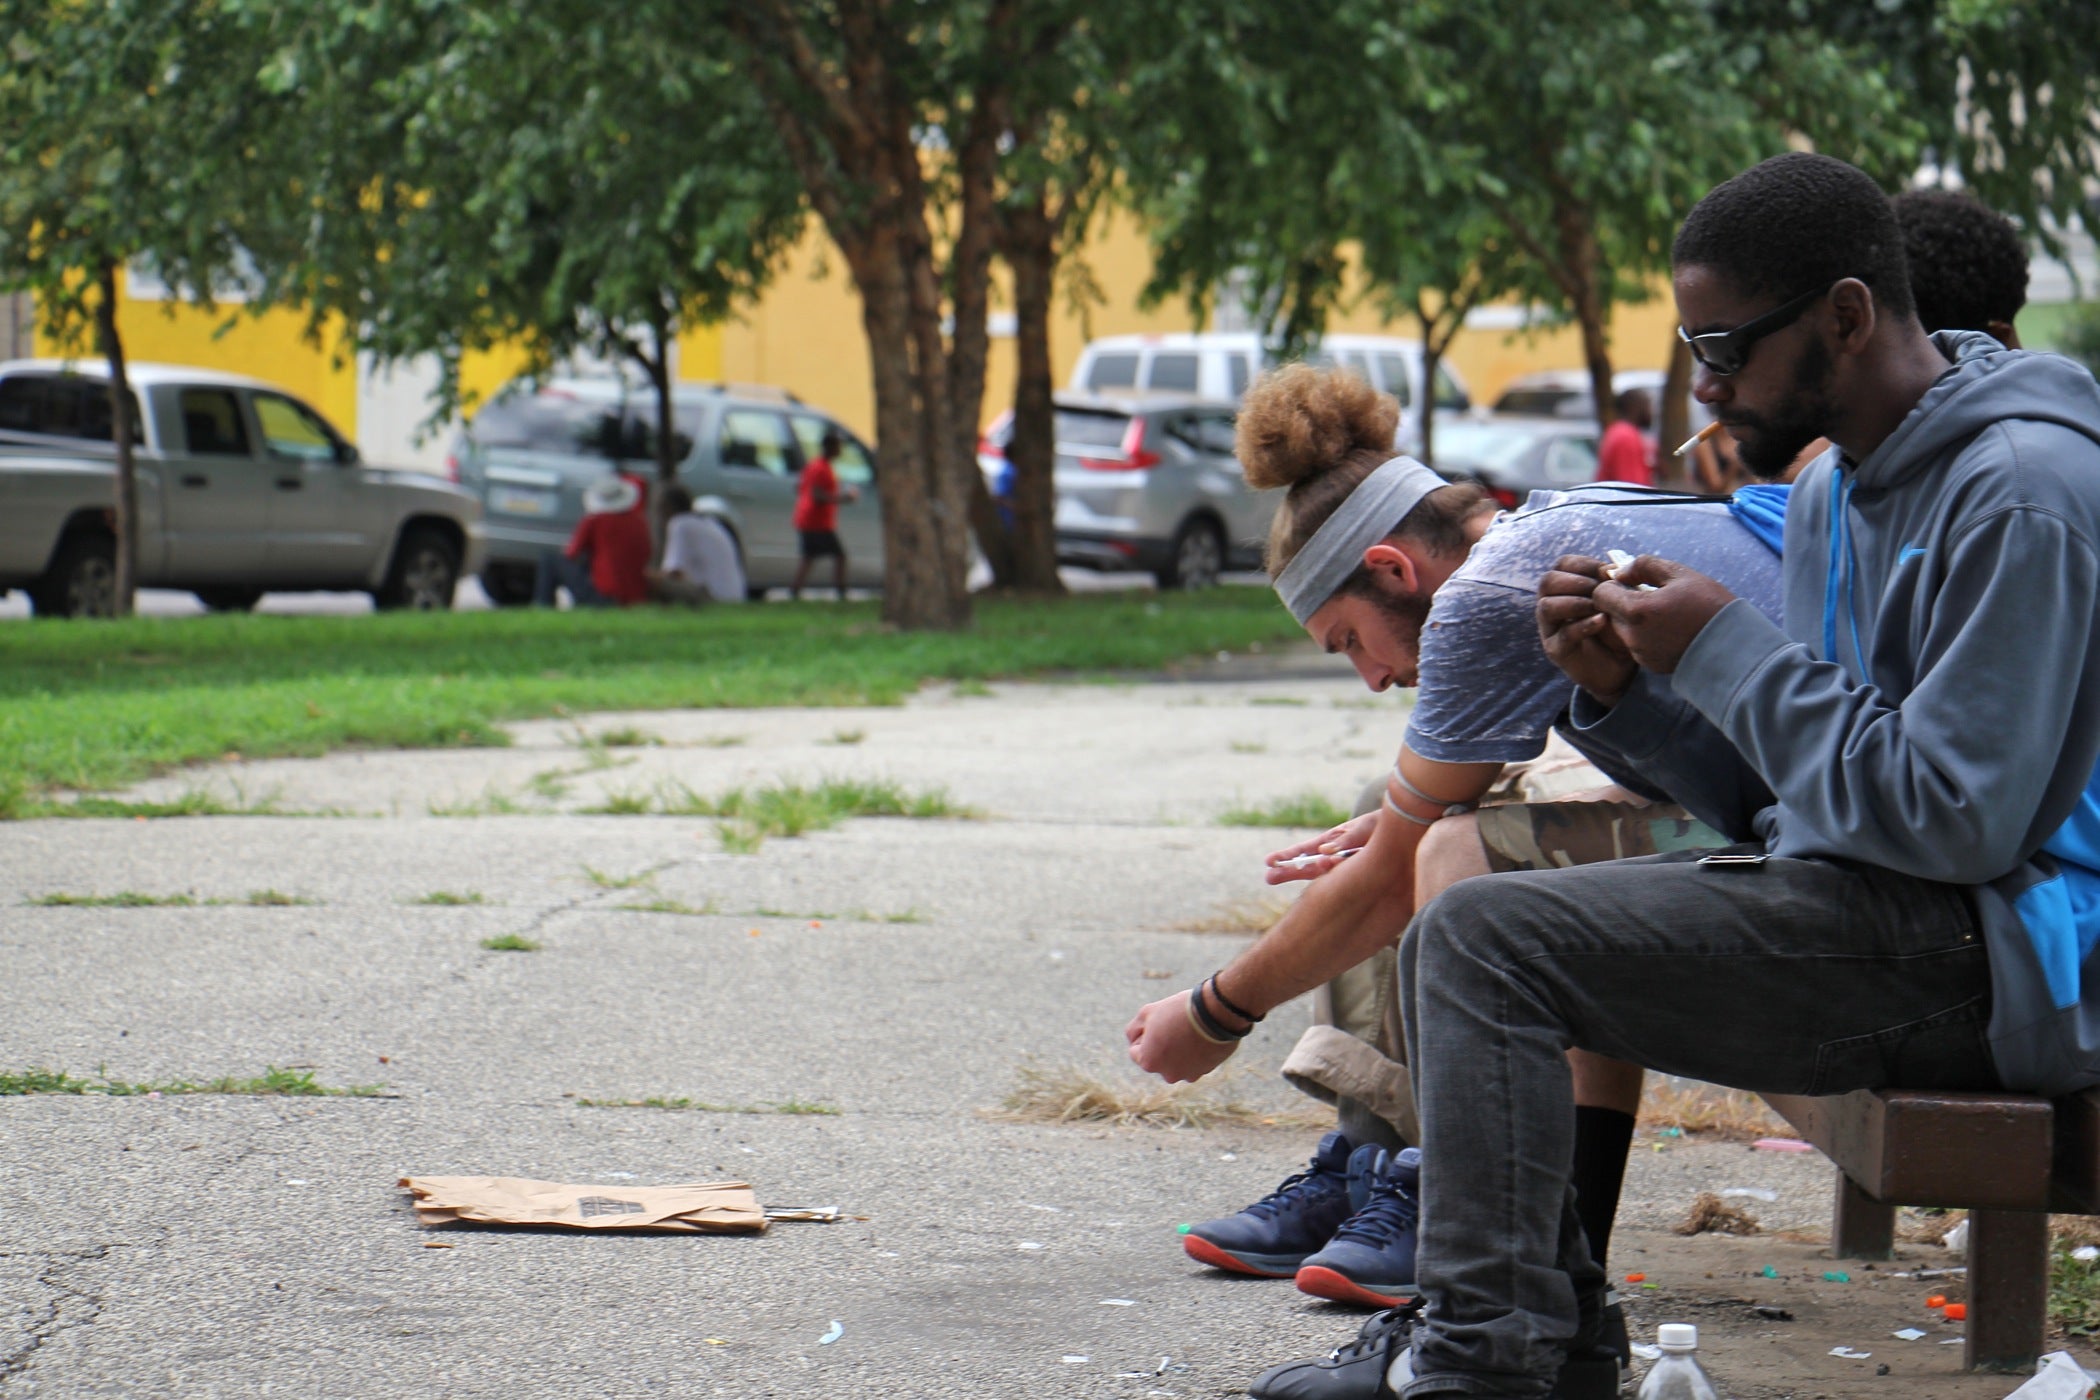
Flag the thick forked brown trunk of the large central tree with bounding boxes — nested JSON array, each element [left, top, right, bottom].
[[687, 0, 1077, 628]]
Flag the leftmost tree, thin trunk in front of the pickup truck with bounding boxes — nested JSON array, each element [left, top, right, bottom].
[[0, 0, 298, 615]]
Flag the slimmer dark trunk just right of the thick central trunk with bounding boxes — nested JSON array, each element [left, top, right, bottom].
[[1006, 193, 1065, 594]]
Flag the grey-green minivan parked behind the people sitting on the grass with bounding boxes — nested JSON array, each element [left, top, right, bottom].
[[452, 376, 882, 604]]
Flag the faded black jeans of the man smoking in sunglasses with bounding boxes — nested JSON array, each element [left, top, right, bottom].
[[1401, 846, 1997, 1396]]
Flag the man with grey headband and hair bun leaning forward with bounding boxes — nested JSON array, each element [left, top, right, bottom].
[[1128, 356, 1783, 1376]]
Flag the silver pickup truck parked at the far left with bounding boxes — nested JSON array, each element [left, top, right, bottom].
[[0, 359, 483, 617]]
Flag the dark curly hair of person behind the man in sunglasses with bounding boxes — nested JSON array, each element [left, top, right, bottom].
[[1890, 189, 2027, 332]]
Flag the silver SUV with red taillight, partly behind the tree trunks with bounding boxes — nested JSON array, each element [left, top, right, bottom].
[[999, 393, 1283, 588]]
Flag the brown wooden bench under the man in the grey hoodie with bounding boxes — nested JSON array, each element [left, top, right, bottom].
[[1764, 1089, 2100, 1369]]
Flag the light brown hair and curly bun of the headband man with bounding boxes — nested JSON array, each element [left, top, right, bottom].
[[1235, 365, 1491, 592]]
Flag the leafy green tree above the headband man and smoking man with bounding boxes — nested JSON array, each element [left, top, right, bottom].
[[1132, 0, 1917, 442]]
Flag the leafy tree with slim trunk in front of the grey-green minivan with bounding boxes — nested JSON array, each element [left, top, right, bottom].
[[247, 0, 806, 497]]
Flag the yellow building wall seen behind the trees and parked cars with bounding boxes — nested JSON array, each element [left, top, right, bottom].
[[36, 225, 1676, 439]]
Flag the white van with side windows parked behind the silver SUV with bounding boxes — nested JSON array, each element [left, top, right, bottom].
[[1071, 332, 1472, 451]]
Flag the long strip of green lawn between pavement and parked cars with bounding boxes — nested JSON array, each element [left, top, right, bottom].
[[0, 588, 1298, 819]]
